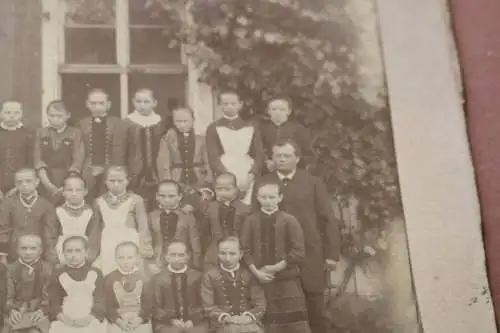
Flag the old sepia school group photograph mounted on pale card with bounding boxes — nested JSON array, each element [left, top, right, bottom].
[[0, 0, 421, 333]]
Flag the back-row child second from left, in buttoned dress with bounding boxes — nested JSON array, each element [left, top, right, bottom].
[[34, 100, 85, 205]]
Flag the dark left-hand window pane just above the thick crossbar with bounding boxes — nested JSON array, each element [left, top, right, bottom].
[[65, 28, 116, 64]]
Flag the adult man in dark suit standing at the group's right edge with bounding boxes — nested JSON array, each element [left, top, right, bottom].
[[254, 140, 340, 333]]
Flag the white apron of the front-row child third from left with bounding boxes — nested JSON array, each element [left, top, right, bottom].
[[108, 281, 153, 333]]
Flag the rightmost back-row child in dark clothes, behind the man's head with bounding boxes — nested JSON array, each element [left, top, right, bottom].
[[260, 97, 312, 172]]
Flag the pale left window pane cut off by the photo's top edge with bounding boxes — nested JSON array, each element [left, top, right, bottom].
[[66, 0, 115, 25]]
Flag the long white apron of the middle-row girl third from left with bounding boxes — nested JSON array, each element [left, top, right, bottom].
[[95, 196, 139, 276]]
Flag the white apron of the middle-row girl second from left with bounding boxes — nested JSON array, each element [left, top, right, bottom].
[[56, 207, 93, 264]]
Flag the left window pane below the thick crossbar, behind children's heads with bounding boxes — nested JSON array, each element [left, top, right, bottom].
[[61, 74, 120, 124]]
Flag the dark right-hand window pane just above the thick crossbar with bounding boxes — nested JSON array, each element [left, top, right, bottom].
[[130, 28, 181, 65]]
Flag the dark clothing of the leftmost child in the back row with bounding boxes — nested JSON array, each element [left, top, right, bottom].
[[0, 127, 34, 194]]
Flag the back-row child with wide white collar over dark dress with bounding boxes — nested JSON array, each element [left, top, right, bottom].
[[125, 88, 166, 211]]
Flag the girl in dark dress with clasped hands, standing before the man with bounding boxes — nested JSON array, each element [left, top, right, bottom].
[[241, 182, 311, 333]]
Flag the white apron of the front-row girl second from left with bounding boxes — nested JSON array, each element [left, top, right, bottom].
[[49, 271, 106, 333]]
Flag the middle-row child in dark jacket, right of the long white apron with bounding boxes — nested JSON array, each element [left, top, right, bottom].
[[149, 180, 201, 268]]
